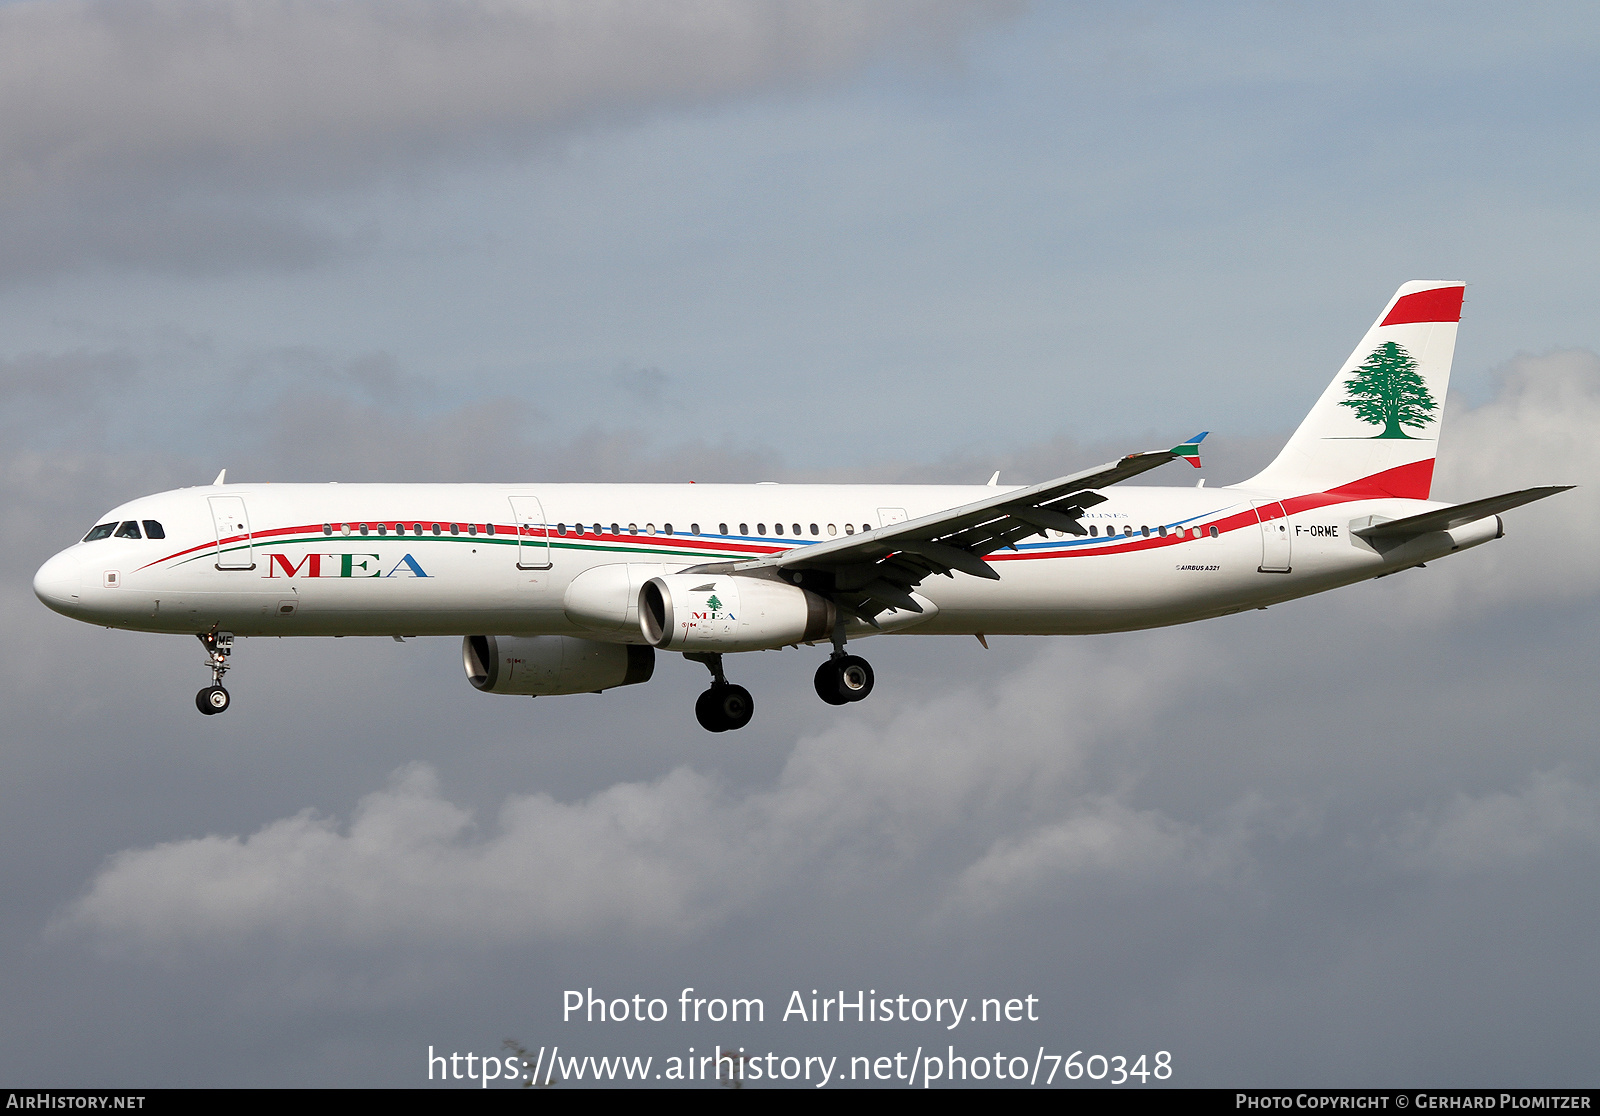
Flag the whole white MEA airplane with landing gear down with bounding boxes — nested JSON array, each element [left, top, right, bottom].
[[34, 281, 1571, 732]]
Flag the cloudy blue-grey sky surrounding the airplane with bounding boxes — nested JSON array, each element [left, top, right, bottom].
[[0, 0, 1600, 1087]]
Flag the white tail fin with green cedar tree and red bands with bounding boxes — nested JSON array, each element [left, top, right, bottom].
[[1240, 281, 1464, 500]]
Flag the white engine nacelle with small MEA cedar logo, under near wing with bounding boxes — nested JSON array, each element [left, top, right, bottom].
[[638, 574, 834, 651]]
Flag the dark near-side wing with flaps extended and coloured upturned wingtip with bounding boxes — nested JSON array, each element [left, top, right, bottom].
[[681, 433, 1205, 627]]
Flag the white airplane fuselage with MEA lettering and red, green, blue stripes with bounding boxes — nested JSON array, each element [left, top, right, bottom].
[[34, 473, 1499, 643]]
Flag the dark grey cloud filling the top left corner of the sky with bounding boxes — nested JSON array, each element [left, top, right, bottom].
[[0, 0, 1014, 275]]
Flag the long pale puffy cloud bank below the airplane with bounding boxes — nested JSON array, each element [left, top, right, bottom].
[[64, 633, 1219, 947]]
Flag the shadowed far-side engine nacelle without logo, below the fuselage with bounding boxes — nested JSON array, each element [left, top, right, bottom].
[[461, 635, 656, 696]]
